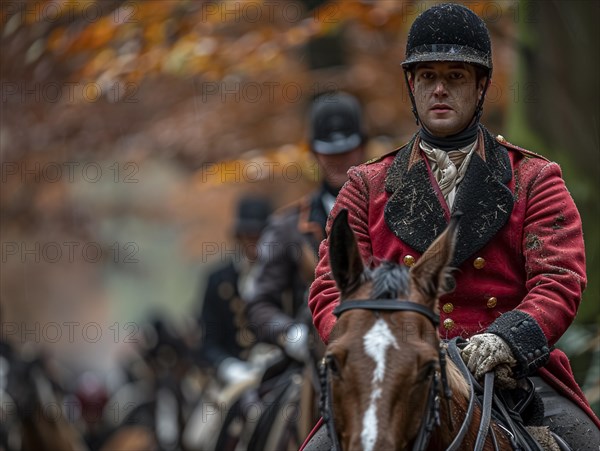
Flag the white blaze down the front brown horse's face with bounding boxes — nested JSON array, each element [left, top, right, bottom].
[[360, 319, 398, 451]]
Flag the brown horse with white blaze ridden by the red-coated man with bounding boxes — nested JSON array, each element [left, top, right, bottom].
[[322, 211, 552, 451]]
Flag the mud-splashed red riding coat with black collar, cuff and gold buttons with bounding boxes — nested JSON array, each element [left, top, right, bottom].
[[308, 127, 600, 427]]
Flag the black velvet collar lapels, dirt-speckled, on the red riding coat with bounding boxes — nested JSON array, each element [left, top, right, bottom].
[[384, 125, 514, 267]]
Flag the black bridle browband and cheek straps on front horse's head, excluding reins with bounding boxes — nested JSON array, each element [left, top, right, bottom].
[[319, 299, 452, 451]]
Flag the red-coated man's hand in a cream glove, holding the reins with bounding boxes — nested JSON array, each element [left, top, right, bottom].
[[462, 333, 517, 379]]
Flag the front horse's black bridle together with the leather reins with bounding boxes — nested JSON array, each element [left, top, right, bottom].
[[319, 299, 541, 451]]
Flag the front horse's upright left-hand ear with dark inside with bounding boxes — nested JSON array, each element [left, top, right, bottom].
[[329, 210, 364, 297]]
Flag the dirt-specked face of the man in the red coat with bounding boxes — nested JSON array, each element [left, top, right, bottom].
[[409, 62, 486, 137]]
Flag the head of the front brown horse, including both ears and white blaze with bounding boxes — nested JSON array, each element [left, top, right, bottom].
[[325, 211, 457, 450]]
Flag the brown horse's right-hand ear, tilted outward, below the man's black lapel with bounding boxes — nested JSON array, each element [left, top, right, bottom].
[[410, 212, 462, 310]]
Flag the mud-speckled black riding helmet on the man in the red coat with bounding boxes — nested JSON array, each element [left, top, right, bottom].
[[402, 3, 492, 76]]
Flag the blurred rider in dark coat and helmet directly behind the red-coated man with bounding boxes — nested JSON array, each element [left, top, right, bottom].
[[242, 92, 366, 361]]
